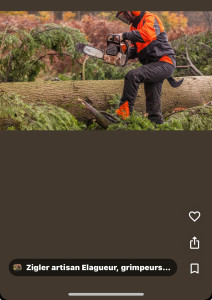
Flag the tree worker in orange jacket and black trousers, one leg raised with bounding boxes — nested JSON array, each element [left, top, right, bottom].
[[116, 11, 176, 124]]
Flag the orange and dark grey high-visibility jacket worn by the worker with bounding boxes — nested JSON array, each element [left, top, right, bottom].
[[123, 11, 176, 67]]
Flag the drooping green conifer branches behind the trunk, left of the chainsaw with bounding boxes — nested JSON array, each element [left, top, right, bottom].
[[0, 24, 86, 82]]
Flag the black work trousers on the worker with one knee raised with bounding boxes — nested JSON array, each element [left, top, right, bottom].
[[120, 61, 175, 124]]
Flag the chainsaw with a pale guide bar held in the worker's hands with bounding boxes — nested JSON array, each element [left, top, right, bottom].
[[76, 34, 129, 67]]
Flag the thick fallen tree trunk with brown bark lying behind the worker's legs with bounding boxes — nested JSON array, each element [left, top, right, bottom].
[[0, 76, 212, 120]]
